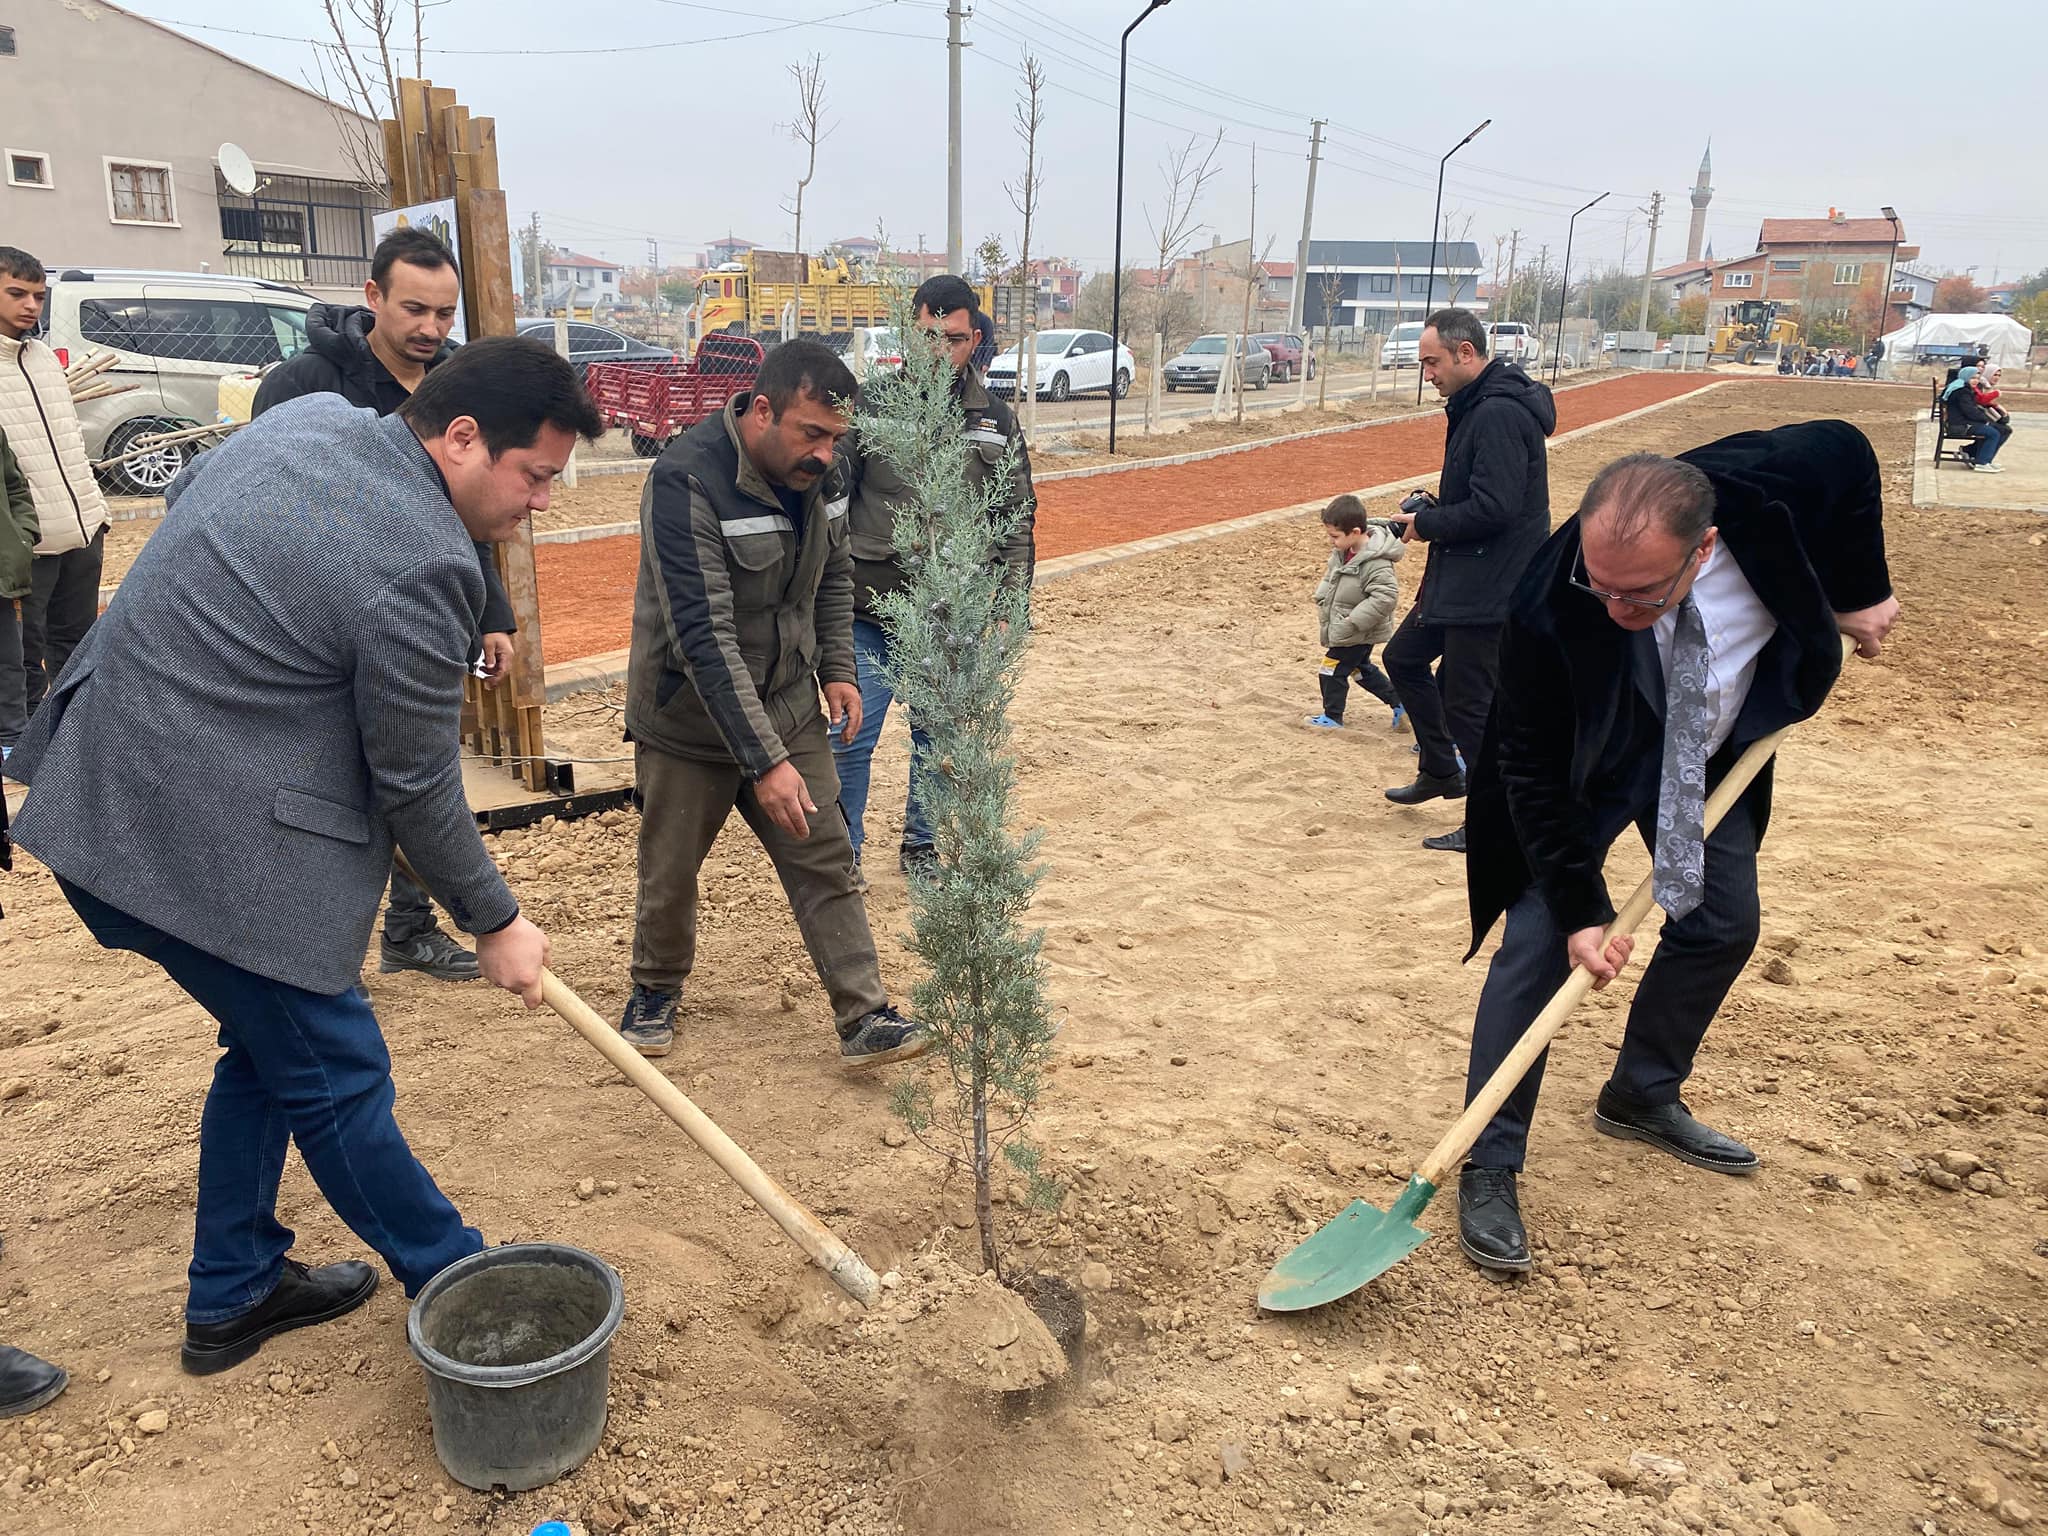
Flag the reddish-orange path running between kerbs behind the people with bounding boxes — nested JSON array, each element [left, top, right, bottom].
[[535, 373, 1712, 662]]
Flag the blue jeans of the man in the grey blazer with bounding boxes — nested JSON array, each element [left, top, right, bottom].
[[59, 881, 483, 1323]]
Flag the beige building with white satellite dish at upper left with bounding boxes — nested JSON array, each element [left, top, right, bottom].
[[0, 0, 387, 299]]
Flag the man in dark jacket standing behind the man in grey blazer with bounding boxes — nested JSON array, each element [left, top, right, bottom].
[[254, 227, 518, 981]]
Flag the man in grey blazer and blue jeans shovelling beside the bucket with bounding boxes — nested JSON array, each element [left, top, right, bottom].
[[8, 336, 602, 1374]]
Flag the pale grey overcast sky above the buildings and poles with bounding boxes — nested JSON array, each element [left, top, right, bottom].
[[135, 0, 2048, 283]]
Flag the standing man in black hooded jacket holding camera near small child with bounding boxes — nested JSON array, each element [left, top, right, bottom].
[[1384, 309, 1556, 854]]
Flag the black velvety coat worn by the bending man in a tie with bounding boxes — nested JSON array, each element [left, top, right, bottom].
[[1464, 422, 1892, 958]]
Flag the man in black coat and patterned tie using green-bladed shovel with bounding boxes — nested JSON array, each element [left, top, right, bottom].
[[1458, 422, 1898, 1272]]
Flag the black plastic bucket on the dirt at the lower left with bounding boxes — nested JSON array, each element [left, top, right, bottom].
[[406, 1243, 627, 1493]]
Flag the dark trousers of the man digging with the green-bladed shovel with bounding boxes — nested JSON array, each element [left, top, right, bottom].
[[1464, 788, 1761, 1169]]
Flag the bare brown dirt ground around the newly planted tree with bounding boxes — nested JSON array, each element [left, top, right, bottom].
[[0, 383, 2048, 1536]]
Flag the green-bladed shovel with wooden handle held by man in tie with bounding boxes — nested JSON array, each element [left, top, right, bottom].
[[1260, 727, 1790, 1313]]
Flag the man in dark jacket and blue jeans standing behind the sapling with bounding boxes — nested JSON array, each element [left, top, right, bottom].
[[831, 286, 1038, 872]]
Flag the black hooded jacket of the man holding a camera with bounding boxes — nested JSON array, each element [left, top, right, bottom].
[[1415, 358, 1556, 625]]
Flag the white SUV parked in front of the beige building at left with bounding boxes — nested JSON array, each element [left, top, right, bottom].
[[43, 266, 315, 496]]
